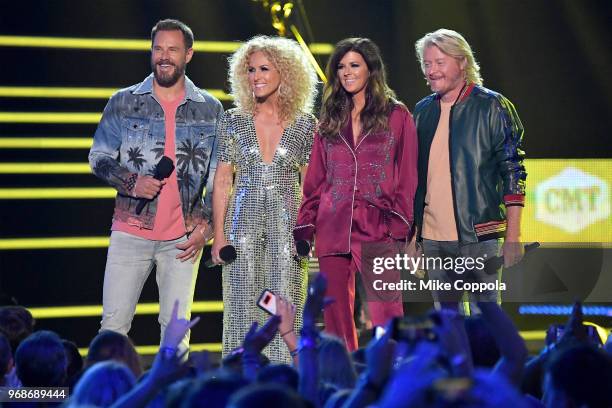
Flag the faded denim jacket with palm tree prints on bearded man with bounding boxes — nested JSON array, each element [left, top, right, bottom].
[[89, 74, 223, 231]]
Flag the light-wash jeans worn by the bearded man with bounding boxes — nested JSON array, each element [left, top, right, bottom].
[[100, 231, 201, 349]]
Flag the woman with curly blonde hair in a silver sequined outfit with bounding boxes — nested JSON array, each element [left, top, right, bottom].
[[212, 36, 317, 363]]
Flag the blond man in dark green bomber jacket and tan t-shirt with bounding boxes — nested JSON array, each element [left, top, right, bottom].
[[414, 29, 527, 308]]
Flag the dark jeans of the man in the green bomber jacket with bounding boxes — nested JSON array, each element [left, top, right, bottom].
[[423, 239, 502, 310]]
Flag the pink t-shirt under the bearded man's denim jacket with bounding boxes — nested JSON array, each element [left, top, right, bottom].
[[111, 93, 186, 241]]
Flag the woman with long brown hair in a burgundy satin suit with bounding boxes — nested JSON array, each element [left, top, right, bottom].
[[294, 38, 417, 351]]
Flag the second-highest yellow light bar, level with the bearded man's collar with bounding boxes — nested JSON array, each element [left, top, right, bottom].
[[0, 86, 232, 101]]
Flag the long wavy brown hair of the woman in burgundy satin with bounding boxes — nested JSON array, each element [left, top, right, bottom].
[[319, 38, 400, 138]]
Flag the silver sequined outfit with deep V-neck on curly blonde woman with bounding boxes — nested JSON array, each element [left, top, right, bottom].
[[217, 109, 315, 363]]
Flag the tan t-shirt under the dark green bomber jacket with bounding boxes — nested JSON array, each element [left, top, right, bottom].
[[421, 101, 458, 241]]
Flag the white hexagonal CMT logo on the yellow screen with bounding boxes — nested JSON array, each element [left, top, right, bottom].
[[535, 167, 610, 233]]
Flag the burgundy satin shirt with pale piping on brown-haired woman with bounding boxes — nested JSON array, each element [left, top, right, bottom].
[[293, 105, 417, 257]]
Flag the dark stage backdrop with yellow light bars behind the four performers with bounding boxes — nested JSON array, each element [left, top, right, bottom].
[[0, 0, 612, 352]]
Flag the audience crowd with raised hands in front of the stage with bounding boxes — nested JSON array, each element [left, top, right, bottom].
[[0, 274, 612, 408]]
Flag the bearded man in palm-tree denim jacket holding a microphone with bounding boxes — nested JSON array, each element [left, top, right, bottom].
[[89, 20, 223, 347]]
